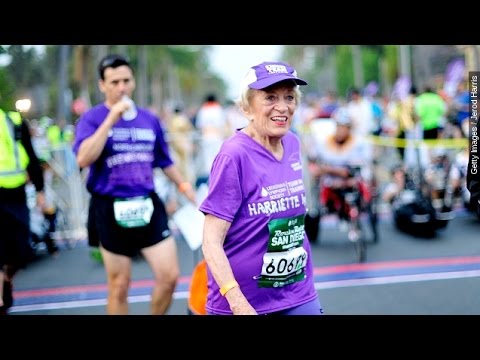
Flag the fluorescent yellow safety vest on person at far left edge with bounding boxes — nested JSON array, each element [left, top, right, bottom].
[[0, 109, 30, 189]]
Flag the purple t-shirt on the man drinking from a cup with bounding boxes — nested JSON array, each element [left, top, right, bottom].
[[73, 103, 173, 198]]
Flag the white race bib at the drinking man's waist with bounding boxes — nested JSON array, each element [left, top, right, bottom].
[[113, 197, 153, 228]]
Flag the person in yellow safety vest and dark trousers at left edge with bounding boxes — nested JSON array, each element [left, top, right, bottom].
[[0, 109, 45, 315]]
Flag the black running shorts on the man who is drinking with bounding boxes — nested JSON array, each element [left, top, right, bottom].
[[87, 192, 171, 257]]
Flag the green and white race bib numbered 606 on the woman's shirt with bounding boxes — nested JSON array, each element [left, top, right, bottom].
[[258, 215, 308, 287]]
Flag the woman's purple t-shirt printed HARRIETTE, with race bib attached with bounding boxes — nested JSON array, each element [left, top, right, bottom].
[[200, 130, 317, 314]]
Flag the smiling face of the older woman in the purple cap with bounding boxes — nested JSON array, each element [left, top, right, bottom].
[[246, 82, 297, 138]]
